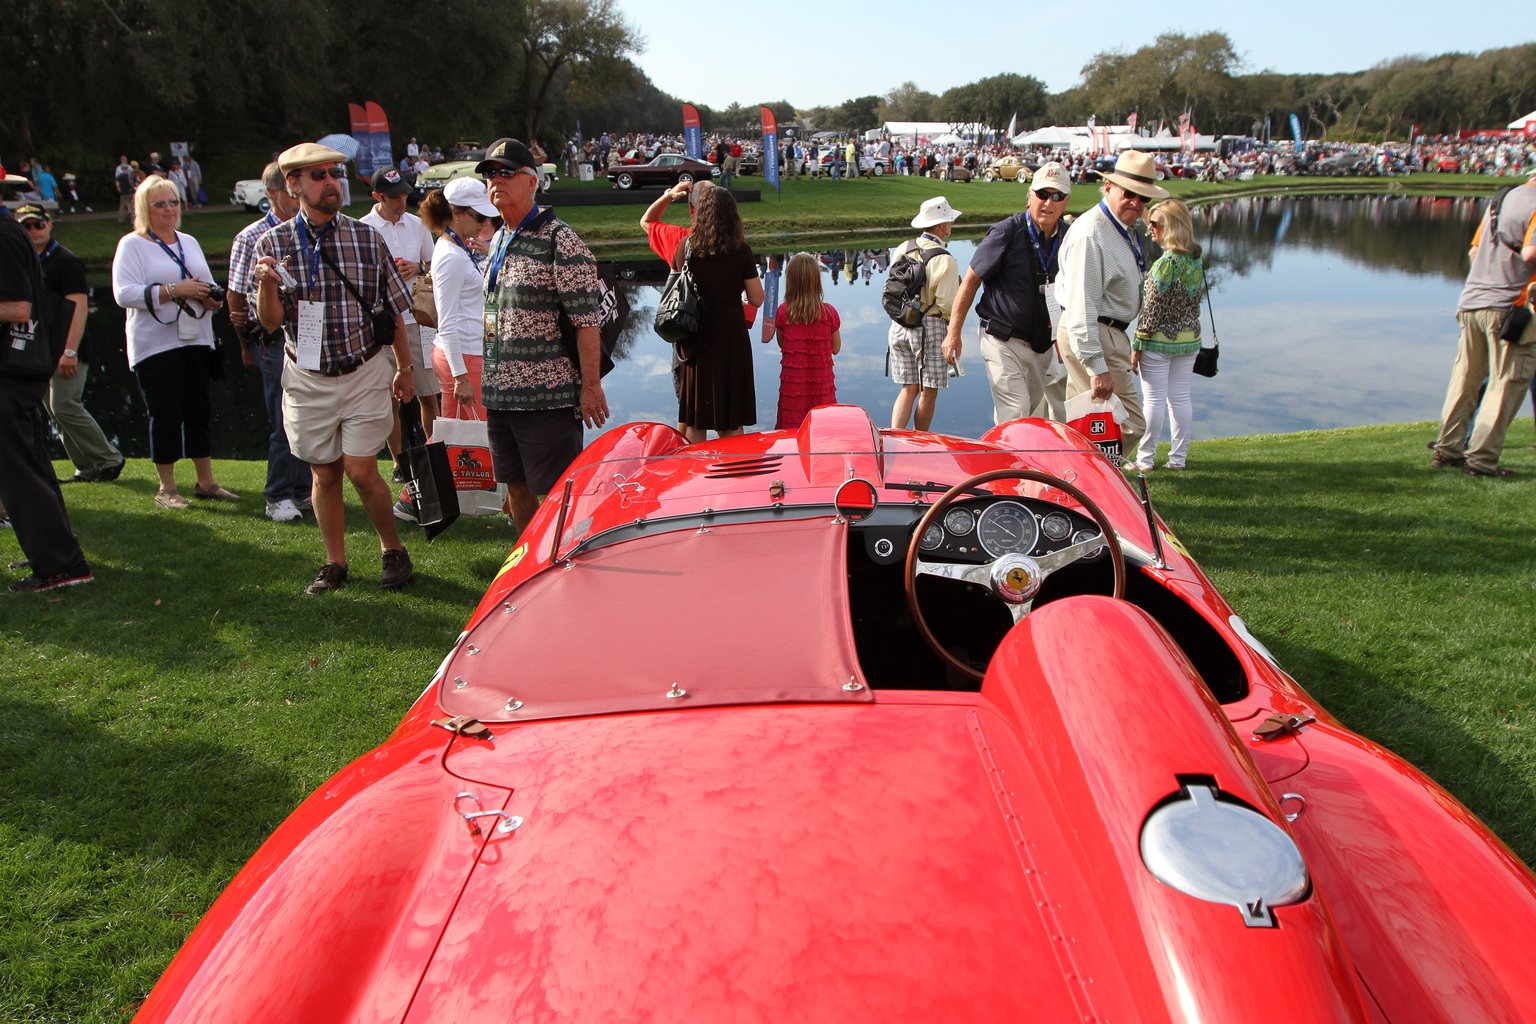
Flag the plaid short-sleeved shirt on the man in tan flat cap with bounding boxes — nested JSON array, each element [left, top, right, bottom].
[[257, 213, 410, 376]]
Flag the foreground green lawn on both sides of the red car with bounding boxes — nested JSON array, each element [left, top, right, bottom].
[[0, 417, 1536, 1022]]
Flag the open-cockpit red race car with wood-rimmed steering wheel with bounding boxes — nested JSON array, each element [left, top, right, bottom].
[[137, 405, 1536, 1024]]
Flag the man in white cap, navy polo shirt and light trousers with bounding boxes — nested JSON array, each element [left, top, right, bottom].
[[945, 161, 1072, 424]]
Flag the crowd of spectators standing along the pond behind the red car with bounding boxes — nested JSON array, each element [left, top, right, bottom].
[[0, 121, 1536, 594]]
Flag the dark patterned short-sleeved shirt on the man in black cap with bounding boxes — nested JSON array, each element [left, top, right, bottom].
[[481, 209, 602, 411]]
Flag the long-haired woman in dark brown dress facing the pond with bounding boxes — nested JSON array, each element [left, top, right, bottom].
[[673, 183, 763, 444]]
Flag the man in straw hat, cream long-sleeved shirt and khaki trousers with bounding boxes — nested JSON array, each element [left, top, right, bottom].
[[1057, 149, 1167, 451]]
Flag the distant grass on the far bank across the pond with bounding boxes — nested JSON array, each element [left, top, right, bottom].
[[54, 173, 1521, 267]]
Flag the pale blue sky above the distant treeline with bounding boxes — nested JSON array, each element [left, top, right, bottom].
[[617, 0, 1524, 109]]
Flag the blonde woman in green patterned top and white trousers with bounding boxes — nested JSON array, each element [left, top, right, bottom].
[[1130, 200, 1206, 473]]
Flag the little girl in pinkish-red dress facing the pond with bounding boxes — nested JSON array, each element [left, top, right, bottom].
[[774, 252, 843, 430]]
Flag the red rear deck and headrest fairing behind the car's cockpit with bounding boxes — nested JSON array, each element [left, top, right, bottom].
[[407, 599, 1362, 1024]]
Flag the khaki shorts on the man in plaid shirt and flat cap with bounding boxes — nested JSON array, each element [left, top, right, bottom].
[[283, 350, 395, 465]]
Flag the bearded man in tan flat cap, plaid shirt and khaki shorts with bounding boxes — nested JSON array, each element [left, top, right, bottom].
[[257, 143, 415, 594]]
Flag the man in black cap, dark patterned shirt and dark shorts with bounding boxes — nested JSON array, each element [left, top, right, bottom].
[[475, 138, 608, 527]]
